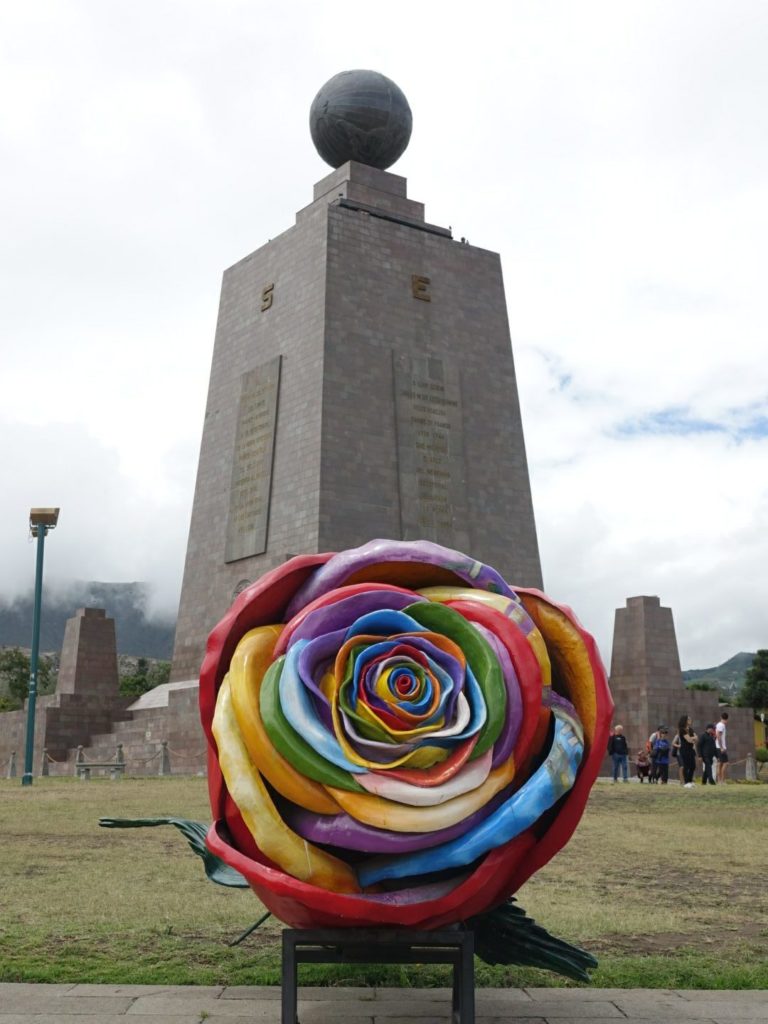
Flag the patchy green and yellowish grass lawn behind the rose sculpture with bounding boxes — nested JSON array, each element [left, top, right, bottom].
[[0, 778, 768, 988]]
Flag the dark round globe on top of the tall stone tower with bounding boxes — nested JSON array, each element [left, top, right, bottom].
[[309, 71, 413, 171]]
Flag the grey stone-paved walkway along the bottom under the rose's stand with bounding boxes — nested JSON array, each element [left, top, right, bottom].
[[0, 983, 768, 1024]]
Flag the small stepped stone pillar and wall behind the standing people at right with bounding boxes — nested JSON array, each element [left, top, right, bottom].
[[604, 597, 755, 777]]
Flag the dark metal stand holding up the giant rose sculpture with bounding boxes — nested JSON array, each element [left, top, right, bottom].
[[282, 928, 475, 1024]]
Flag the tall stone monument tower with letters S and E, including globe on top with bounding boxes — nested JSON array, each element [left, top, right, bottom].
[[171, 71, 542, 681]]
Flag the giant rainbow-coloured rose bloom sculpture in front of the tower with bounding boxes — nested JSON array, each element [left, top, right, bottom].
[[200, 541, 612, 929]]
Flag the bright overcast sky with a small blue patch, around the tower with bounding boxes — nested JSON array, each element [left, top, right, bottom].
[[0, 0, 768, 668]]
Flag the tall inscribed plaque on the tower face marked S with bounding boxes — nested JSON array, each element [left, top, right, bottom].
[[224, 355, 281, 562]]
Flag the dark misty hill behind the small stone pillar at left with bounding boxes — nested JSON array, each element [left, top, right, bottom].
[[0, 582, 176, 660]]
